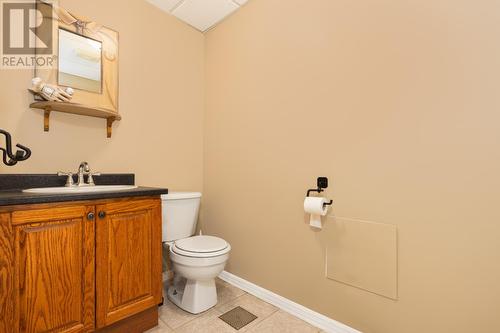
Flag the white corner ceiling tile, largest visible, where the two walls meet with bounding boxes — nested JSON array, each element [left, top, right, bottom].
[[172, 0, 239, 31]]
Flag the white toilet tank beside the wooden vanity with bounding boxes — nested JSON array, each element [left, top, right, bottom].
[[161, 192, 201, 242]]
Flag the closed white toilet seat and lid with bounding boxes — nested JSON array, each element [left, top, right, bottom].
[[171, 236, 231, 258]]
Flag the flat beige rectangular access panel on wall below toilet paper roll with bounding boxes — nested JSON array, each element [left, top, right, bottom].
[[326, 217, 398, 299]]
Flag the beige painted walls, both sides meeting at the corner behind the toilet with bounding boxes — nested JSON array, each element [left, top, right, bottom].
[[0, 0, 500, 333]]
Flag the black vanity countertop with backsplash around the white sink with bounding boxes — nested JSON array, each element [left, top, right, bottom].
[[0, 174, 168, 206]]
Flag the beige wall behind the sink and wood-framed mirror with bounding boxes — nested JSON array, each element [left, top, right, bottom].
[[0, 0, 204, 190]]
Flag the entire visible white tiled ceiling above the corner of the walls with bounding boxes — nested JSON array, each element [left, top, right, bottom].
[[146, 0, 248, 32]]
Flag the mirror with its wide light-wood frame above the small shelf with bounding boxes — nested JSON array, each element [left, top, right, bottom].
[[34, 0, 119, 114]]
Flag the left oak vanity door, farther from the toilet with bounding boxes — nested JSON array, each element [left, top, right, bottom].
[[12, 206, 95, 333]]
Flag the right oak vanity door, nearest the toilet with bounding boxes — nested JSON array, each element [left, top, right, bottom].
[[96, 198, 162, 328]]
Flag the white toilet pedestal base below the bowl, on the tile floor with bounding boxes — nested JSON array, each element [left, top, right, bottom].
[[167, 278, 217, 314]]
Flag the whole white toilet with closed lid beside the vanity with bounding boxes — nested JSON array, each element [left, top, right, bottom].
[[162, 192, 231, 314]]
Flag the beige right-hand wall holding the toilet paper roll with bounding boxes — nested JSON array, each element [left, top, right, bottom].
[[203, 0, 500, 333]]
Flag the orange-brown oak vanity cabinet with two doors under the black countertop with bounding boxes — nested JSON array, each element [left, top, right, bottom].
[[0, 197, 162, 333]]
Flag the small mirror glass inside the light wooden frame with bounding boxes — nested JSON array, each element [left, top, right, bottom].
[[58, 28, 102, 93]]
